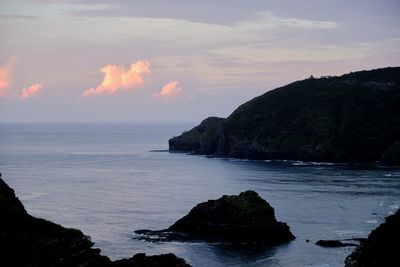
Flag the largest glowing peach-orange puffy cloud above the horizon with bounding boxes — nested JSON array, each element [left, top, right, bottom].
[[82, 60, 151, 96]]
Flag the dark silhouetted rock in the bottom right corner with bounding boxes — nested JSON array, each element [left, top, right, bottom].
[[345, 210, 400, 267]]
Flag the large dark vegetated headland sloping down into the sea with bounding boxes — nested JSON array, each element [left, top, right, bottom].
[[169, 67, 400, 165]]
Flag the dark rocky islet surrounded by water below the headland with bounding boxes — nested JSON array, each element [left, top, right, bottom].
[[136, 191, 295, 245]]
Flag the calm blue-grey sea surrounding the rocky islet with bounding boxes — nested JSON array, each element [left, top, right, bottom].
[[0, 123, 400, 267]]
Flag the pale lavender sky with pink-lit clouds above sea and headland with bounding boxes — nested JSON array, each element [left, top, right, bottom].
[[0, 0, 400, 123]]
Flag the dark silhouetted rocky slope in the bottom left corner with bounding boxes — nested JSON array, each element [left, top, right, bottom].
[[0, 178, 189, 267]]
